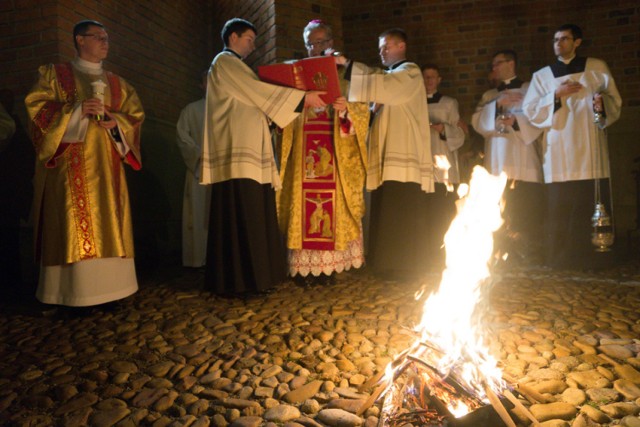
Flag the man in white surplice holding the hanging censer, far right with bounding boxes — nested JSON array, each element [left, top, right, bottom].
[[523, 24, 622, 269]]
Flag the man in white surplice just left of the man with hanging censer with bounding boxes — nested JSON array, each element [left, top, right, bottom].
[[471, 49, 544, 263]]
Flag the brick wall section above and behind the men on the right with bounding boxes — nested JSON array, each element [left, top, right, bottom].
[[342, 0, 640, 116]]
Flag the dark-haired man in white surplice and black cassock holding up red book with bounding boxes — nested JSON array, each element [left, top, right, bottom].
[[200, 18, 325, 295]]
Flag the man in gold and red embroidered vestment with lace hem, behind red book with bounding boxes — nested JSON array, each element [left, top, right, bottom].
[[277, 20, 369, 285]]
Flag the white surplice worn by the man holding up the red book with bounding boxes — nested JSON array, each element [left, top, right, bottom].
[[200, 50, 305, 189]]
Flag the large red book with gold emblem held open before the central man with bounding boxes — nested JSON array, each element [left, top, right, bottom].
[[258, 56, 340, 104]]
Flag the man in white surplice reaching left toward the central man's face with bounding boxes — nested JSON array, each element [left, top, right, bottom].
[[337, 29, 434, 278]]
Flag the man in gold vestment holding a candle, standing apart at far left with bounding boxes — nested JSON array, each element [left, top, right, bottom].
[[25, 21, 144, 307]]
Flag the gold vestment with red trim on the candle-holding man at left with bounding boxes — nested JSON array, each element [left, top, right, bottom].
[[25, 59, 144, 268]]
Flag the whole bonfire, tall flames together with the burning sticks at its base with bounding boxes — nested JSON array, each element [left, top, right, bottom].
[[370, 167, 507, 424]]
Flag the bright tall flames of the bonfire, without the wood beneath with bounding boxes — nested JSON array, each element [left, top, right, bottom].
[[416, 168, 507, 406]]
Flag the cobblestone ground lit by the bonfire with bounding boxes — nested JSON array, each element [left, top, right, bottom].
[[0, 263, 640, 427]]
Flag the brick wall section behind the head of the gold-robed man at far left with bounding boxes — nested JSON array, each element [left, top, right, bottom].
[[0, 0, 211, 122]]
